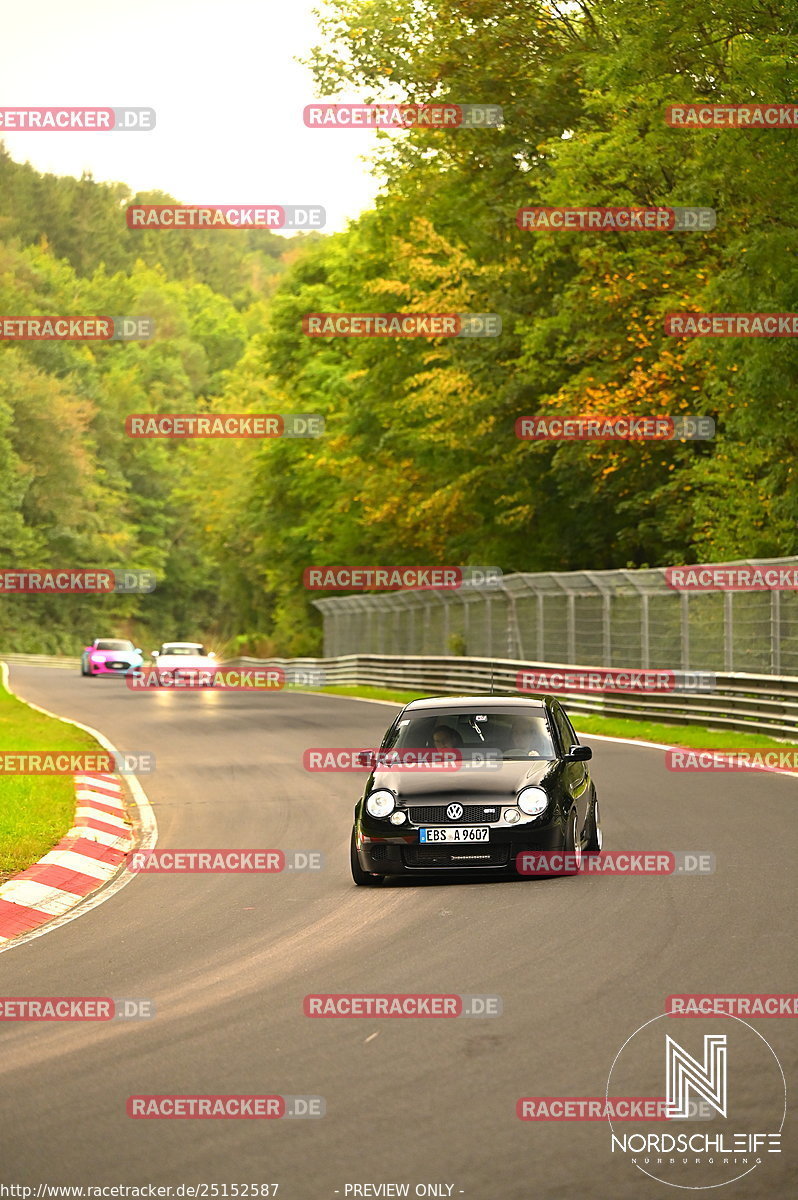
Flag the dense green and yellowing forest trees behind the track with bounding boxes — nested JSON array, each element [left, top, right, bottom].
[[0, 0, 798, 655]]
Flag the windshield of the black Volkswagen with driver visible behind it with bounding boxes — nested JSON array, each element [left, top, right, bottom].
[[385, 706, 556, 758]]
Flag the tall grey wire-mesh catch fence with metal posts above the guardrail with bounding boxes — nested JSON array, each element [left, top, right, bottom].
[[314, 557, 798, 676]]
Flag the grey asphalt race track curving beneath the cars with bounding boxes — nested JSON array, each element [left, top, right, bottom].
[[0, 666, 798, 1200]]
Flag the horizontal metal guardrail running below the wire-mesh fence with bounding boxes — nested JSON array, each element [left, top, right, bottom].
[[227, 654, 798, 738]]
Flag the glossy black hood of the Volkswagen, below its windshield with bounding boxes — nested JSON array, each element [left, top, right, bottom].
[[367, 758, 557, 804]]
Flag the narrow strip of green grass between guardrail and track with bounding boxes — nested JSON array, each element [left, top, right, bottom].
[[300, 686, 798, 750]]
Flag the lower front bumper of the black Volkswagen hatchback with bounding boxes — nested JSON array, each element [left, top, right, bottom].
[[355, 821, 564, 875]]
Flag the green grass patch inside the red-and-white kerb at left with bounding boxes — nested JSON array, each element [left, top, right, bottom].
[[0, 686, 101, 883]]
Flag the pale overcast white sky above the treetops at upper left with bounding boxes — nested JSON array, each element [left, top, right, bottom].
[[0, 0, 377, 232]]
